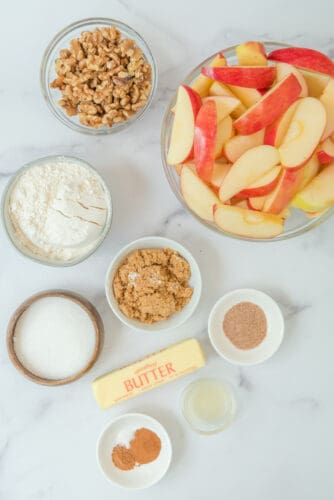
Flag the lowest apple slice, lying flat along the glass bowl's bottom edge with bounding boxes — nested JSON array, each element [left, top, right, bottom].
[[213, 205, 283, 238]]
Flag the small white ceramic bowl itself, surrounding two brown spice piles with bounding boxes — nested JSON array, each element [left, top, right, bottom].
[[96, 413, 172, 490]]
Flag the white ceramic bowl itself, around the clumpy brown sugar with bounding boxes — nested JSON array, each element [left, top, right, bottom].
[[105, 236, 202, 332]]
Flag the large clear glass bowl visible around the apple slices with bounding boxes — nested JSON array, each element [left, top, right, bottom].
[[161, 42, 334, 242]]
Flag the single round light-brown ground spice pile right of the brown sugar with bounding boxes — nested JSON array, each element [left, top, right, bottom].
[[223, 302, 267, 350]]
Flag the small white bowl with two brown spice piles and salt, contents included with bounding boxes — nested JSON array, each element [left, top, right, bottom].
[[96, 413, 172, 490]]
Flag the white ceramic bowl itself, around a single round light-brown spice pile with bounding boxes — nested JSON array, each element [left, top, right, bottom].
[[208, 288, 284, 365]]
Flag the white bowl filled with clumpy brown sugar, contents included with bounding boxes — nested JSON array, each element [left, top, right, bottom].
[[105, 236, 202, 331]]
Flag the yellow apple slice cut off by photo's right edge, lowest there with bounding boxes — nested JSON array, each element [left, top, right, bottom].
[[292, 163, 334, 212]]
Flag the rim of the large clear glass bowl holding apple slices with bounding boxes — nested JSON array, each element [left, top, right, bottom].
[[160, 40, 334, 243]]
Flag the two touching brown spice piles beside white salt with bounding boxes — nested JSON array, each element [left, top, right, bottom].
[[111, 427, 161, 471]]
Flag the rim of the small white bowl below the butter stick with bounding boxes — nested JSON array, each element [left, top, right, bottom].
[[95, 412, 173, 491]]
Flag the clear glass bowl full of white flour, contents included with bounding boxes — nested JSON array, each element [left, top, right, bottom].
[[2, 156, 112, 266]]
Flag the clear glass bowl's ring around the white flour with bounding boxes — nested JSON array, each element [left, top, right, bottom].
[[1, 155, 113, 267]]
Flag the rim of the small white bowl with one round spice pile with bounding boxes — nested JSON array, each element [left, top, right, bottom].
[[208, 288, 285, 366]]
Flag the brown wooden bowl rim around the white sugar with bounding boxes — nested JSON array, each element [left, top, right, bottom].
[[7, 289, 104, 387]]
